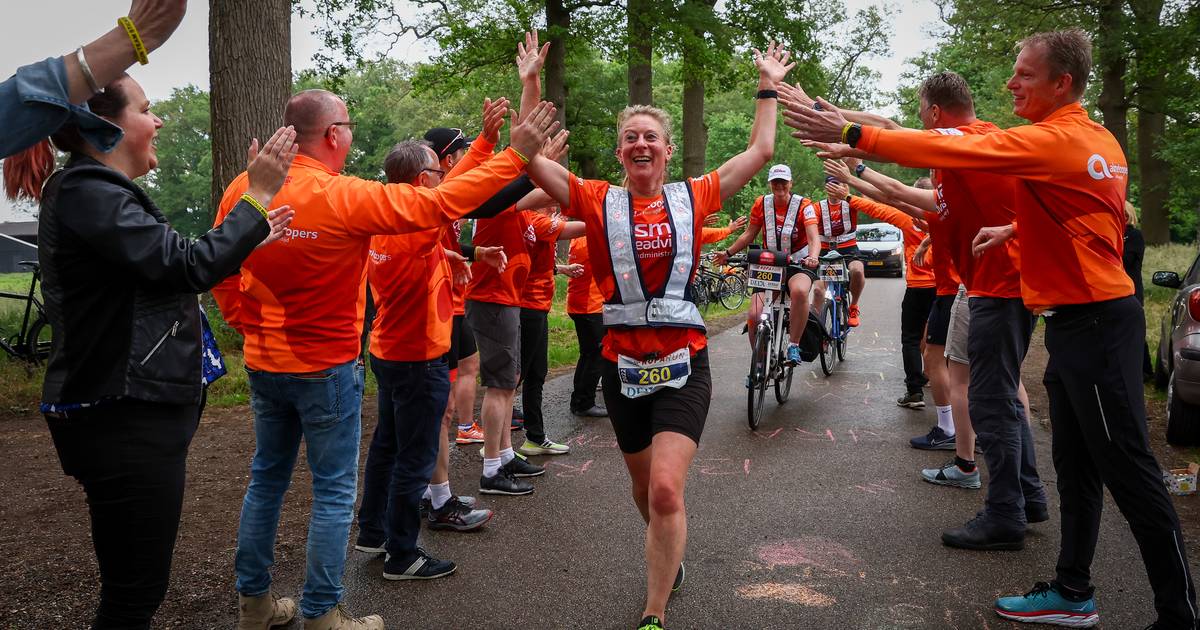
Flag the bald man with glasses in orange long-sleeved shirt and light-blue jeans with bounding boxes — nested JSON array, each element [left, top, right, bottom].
[[212, 90, 553, 629]]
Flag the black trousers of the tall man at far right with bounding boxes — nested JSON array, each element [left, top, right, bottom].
[[1044, 295, 1196, 630]]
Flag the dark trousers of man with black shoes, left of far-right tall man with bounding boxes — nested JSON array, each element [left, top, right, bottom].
[[967, 298, 1046, 529]]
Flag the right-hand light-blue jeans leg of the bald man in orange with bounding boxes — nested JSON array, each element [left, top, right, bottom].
[[288, 361, 364, 619]]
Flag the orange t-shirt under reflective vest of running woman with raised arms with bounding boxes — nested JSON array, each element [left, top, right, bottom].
[[566, 170, 721, 361]]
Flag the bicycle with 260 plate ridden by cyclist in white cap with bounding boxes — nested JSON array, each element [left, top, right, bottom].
[[742, 250, 796, 431]]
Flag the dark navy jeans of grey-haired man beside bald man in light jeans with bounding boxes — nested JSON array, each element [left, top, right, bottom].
[[359, 356, 450, 562]]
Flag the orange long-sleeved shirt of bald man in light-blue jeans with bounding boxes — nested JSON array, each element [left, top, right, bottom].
[[212, 150, 524, 373]]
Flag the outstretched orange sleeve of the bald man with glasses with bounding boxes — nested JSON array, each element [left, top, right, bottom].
[[325, 149, 524, 236]]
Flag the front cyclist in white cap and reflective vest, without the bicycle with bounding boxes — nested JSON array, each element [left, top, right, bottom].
[[714, 164, 821, 364]]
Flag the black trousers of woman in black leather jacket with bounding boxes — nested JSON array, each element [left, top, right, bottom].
[[46, 401, 200, 630]]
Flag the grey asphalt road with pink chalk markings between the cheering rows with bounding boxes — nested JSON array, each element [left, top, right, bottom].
[[336, 277, 1200, 629]]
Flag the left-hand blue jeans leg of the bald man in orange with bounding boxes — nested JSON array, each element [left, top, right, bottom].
[[234, 370, 301, 596]]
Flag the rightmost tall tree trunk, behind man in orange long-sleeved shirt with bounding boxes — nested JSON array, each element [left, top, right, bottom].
[[1130, 0, 1171, 245]]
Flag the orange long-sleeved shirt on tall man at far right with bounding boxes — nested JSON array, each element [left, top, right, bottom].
[[857, 103, 1133, 312]]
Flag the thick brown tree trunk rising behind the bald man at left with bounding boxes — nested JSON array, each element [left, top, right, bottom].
[[209, 0, 292, 214]]
